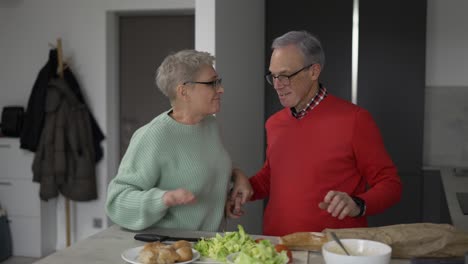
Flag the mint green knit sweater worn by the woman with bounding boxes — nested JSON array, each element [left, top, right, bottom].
[[106, 110, 232, 231]]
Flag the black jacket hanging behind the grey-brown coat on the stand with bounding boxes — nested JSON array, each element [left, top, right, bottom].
[[20, 49, 104, 162]]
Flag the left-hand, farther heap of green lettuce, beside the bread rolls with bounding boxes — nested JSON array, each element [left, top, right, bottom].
[[194, 225, 255, 262]]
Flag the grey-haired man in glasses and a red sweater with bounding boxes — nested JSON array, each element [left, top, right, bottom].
[[227, 31, 402, 236]]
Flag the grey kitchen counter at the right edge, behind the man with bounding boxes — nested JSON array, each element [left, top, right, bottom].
[[440, 168, 468, 231]]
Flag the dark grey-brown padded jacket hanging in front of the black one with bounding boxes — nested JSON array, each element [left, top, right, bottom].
[[33, 79, 97, 201]]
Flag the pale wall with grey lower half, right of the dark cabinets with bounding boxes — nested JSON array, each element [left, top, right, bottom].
[[423, 0, 468, 167]]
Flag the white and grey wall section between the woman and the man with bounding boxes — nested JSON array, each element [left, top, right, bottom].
[[195, 0, 265, 234]]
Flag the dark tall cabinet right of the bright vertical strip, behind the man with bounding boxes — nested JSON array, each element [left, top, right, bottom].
[[358, 0, 427, 225]]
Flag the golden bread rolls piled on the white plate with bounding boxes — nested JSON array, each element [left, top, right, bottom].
[[138, 240, 193, 264]]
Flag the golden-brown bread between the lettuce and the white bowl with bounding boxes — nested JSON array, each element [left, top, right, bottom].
[[280, 232, 328, 251]]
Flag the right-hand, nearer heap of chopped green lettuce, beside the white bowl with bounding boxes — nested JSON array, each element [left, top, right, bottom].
[[234, 240, 289, 264]]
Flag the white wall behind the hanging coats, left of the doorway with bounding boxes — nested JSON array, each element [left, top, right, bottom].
[[0, 0, 194, 248]]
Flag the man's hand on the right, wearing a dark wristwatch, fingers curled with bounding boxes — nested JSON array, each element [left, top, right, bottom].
[[319, 191, 360, 220]]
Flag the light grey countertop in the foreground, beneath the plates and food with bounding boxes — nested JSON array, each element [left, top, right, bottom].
[[35, 225, 410, 264]]
